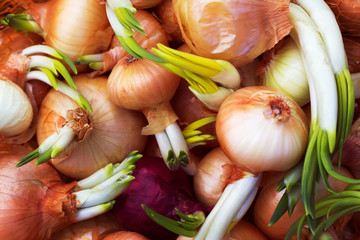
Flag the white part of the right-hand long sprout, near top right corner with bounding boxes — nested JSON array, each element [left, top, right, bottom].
[[296, 0, 346, 74]]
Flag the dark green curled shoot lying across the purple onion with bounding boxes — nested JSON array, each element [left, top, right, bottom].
[[141, 204, 205, 237]]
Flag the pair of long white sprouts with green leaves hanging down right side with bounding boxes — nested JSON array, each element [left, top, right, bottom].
[[275, 0, 360, 232]]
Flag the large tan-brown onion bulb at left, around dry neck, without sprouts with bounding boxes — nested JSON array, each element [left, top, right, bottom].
[[37, 74, 146, 179]]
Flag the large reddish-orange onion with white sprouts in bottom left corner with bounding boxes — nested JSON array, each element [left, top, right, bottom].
[[0, 145, 135, 240]]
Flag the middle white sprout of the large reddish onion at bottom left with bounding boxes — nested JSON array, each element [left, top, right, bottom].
[[73, 175, 135, 208]]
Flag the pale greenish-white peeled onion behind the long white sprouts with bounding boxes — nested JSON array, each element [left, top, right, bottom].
[[260, 38, 310, 106]]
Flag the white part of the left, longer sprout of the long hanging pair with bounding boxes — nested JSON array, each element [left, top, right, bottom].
[[289, 3, 338, 149]]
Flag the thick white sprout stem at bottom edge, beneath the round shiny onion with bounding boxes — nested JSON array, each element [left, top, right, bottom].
[[195, 173, 262, 240]]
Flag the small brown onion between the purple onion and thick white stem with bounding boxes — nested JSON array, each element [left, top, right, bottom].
[[194, 147, 234, 207]]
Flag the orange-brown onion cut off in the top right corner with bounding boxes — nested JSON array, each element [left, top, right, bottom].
[[325, 0, 360, 35]]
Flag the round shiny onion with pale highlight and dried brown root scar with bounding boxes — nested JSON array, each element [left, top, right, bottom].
[[216, 86, 309, 172]]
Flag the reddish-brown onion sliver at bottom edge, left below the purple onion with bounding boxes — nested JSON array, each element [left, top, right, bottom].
[[52, 213, 121, 240]]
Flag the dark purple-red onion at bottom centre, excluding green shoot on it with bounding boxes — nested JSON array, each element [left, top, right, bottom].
[[112, 157, 201, 240]]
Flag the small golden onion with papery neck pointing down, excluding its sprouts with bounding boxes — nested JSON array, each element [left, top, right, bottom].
[[107, 56, 180, 135]]
